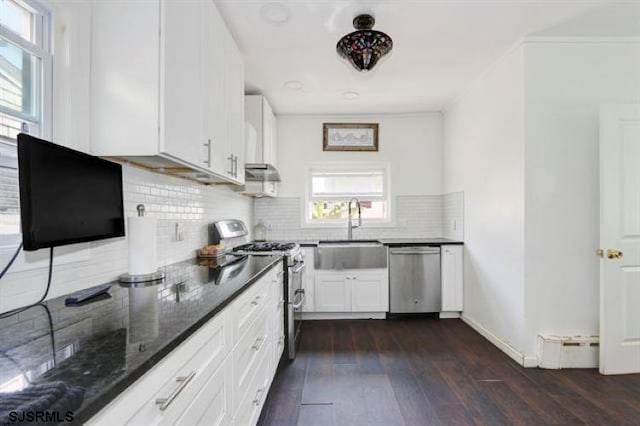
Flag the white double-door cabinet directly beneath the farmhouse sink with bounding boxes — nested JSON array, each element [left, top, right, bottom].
[[315, 269, 389, 312]]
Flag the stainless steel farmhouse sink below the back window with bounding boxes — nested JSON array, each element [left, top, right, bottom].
[[314, 240, 388, 271]]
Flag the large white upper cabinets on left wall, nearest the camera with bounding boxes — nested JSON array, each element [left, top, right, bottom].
[[91, 0, 245, 184]]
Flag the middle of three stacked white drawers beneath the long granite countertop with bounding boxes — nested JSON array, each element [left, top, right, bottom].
[[232, 309, 271, 408]]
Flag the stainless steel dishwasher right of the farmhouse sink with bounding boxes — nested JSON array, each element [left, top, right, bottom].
[[389, 246, 442, 313]]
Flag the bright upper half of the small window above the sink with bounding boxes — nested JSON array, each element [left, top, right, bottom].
[[311, 172, 384, 197]]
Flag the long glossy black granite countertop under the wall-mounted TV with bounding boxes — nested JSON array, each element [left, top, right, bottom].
[[0, 256, 282, 424]]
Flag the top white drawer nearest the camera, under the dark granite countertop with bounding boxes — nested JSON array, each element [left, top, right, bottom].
[[87, 310, 231, 425]]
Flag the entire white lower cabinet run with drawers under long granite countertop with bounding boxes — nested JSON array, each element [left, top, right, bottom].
[[87, 264, 284, 426]]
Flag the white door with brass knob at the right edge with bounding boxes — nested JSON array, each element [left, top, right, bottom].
[[600, 105, 640, 374]]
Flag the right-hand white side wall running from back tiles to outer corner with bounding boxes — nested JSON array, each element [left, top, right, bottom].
[[444, 47, 524, 351]]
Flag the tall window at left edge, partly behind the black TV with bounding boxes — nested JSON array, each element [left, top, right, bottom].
[[0, 0, 52, 246]]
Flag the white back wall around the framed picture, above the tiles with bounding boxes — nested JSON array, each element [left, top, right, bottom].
[[278, 112, 442, 197]]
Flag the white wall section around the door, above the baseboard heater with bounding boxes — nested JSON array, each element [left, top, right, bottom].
[[525, 41, 640, 354]]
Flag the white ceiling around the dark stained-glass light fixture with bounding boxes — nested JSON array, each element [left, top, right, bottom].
[[216, 0, 612, 114]]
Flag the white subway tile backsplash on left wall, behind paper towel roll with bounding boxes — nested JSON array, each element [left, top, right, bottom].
[[0, 166, 253, 312]]
